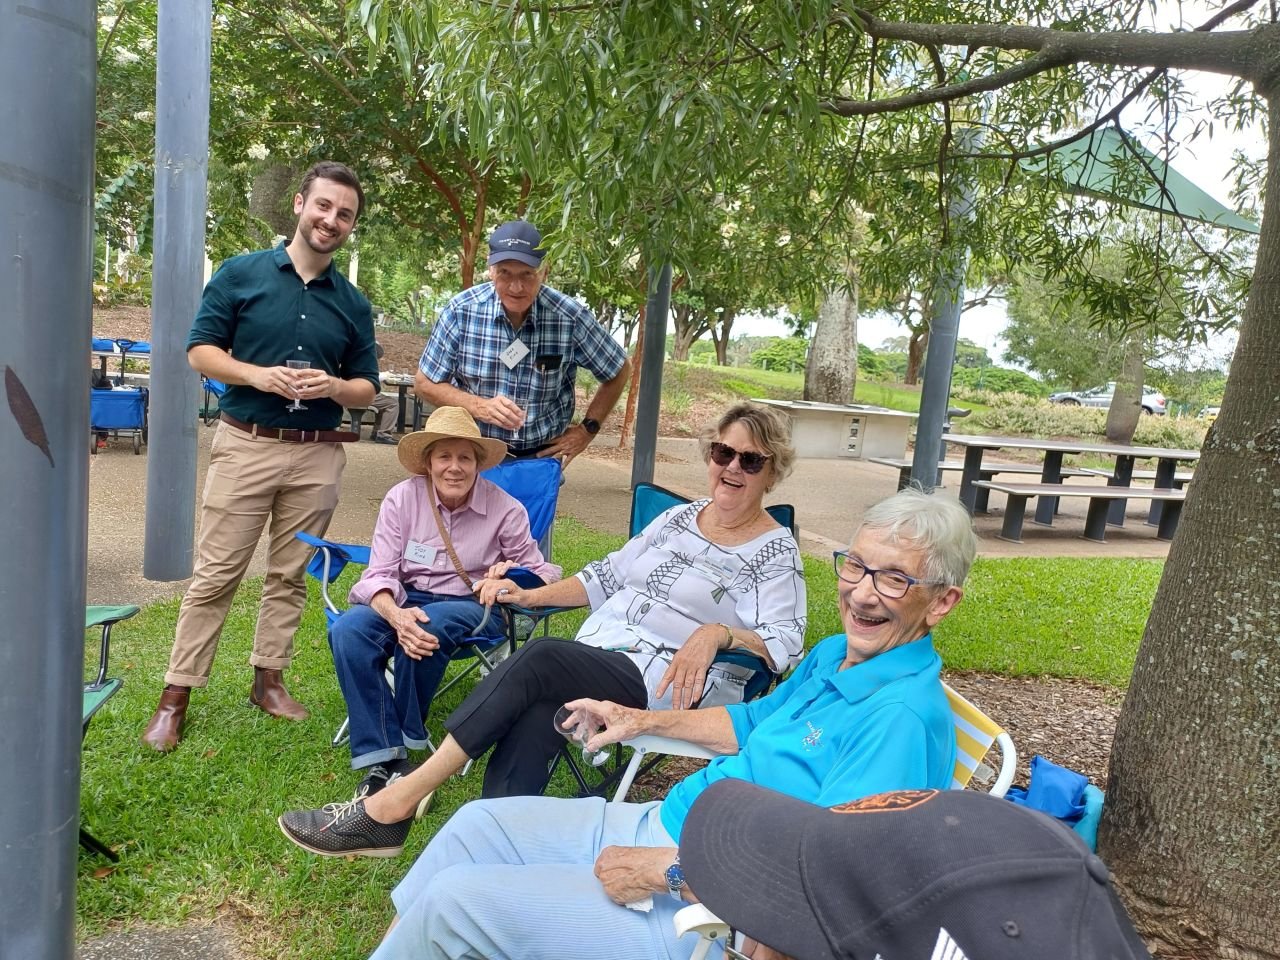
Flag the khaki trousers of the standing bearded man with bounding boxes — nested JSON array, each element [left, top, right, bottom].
[[165, 422, 347, 686]]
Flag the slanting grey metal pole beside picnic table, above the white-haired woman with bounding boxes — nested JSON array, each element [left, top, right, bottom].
[[911, 131, 978, 490]]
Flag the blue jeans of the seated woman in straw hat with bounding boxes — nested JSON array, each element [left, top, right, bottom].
[[329, 589, 502, 769]]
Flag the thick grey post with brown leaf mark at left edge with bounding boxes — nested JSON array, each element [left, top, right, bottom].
[[0, 0, 97, 960]]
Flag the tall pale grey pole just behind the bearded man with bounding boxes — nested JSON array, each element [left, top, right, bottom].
[[142, 0, 212, 580]]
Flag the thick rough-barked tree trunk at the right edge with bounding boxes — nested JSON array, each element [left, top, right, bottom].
[[1100, 91, 1280, 959]]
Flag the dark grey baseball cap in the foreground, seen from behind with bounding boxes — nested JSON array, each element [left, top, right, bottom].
[[680, 780, 1149, 960]]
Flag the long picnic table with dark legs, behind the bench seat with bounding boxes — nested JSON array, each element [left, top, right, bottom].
[[942, 434, 1199, 526]]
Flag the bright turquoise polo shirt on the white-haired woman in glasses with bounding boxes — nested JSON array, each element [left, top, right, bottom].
[[662, 634, 956, 841]]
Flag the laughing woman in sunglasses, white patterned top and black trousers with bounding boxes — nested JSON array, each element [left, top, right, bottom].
[[280, 403, 806, 855]]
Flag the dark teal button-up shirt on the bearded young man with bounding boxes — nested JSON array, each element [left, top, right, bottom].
[[187, 243, 381, 430]]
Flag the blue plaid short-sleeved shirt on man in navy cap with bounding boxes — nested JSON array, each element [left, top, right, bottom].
[[419, 283, 627, 451]]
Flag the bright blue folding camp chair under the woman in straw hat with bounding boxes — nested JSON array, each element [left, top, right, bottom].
[[296, 457, 561, 751]]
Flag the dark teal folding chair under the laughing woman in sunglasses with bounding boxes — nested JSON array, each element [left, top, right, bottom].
[[552, 481, 797, 800]]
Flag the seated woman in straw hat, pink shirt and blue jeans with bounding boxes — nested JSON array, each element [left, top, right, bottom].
[[329, 407, 561, 794]]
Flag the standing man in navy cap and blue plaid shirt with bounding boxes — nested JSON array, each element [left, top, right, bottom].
[[413, 220, 631, 465]]
